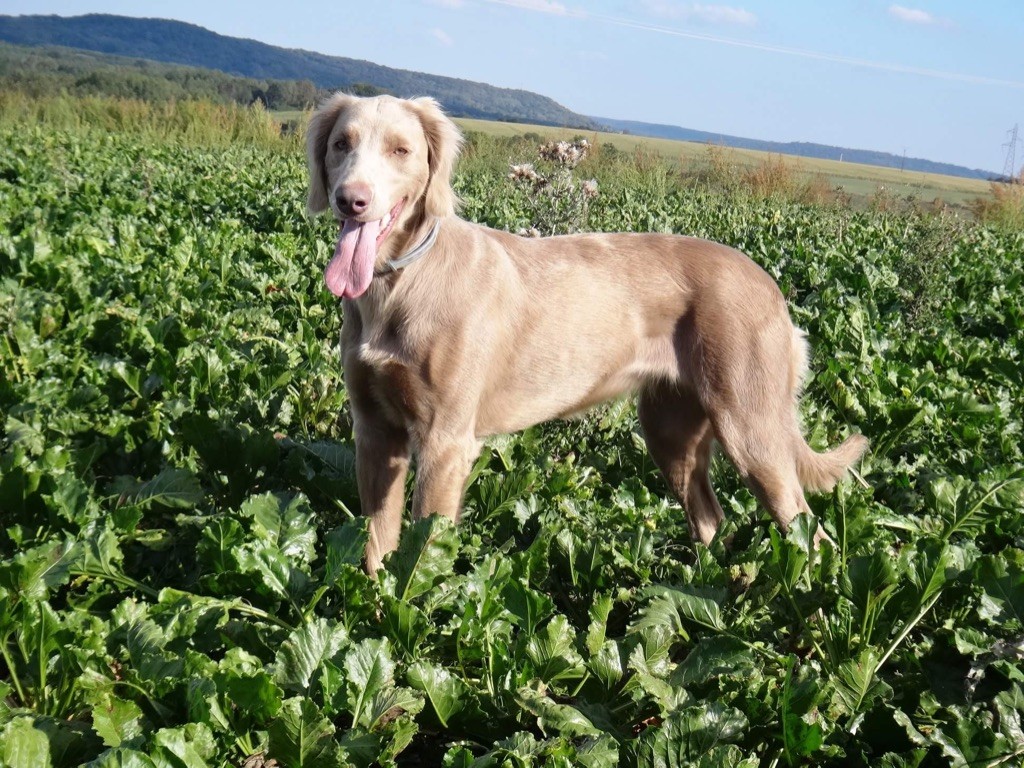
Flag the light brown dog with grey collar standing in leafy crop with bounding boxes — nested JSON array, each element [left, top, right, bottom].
[[307, 94, 867, 572]]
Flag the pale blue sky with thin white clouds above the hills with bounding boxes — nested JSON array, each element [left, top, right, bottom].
[[8, 0, 1024, 172]]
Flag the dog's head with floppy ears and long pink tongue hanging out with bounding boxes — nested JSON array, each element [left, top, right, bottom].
[[306, 93, 462, 299]]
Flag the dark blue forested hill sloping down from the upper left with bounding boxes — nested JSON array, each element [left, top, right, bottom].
[[0, 14, 596, 128]]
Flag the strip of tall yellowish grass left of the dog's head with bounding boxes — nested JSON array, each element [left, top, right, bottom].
[[0, 90, 297, 150]]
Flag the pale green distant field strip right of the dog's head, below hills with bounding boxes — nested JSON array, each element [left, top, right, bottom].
[[455, 118, 990, 207]]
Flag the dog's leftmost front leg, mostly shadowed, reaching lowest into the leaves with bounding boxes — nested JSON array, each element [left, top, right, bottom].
[[355, 420, 410, 574]]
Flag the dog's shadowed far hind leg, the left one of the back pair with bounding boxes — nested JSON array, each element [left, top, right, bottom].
[[637, 383, 724, 544]]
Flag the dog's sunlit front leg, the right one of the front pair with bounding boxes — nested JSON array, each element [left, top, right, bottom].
[[413, 433, 480, 521]]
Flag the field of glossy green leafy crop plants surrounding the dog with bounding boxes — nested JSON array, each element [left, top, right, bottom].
[[0, 127, 1024, 768]]
